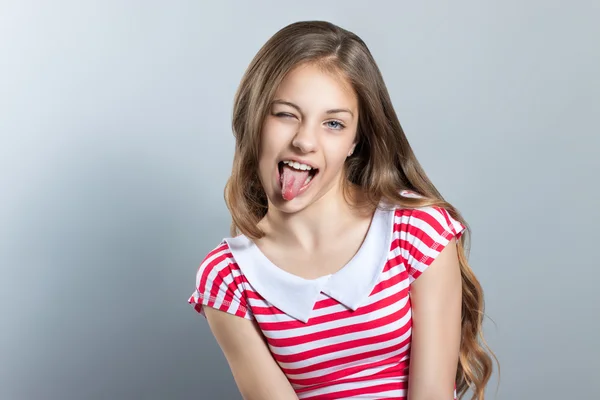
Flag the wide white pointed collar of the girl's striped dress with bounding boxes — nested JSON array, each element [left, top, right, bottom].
[[224, 207, 394, 323]]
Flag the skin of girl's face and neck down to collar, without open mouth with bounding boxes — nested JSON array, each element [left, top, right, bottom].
[[256, 65, 372, 279]]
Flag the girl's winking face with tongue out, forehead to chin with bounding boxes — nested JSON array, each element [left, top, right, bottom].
[[259, 64, 358, 213]]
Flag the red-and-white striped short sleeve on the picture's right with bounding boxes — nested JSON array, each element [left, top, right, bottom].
[[395, 206, 465, 283]]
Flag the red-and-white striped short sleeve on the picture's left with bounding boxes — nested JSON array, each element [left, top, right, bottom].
[[188, 241, 254, 320]]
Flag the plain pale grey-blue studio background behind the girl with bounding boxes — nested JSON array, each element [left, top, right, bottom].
[[0, 0, 600, 400]]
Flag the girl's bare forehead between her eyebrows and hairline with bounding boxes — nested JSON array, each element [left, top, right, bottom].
[[275, 64, 358, 110]]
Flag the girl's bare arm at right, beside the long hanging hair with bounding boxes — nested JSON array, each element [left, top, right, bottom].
[[408, 238, 462, 400]]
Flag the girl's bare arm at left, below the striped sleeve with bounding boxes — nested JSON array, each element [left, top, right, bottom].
[[204, 307, 298, 400]]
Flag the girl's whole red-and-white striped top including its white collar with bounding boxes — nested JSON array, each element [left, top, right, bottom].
[[188, 191, 465, 399]]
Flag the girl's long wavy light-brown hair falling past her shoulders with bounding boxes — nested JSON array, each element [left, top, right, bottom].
[[225, 21, 497, 400]]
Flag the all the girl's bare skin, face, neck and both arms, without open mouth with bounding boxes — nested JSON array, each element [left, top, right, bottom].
[[205, 61, 461, 400]]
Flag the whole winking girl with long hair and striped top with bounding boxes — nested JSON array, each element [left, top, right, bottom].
[[189, 21, 492, 400]]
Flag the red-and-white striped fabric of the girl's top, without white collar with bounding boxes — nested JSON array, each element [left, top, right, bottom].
[[188, 207, 465, 399]]
